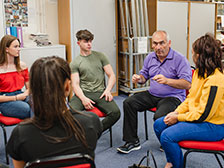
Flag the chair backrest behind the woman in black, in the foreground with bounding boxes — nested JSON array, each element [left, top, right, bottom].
[[24, 153, 95, 168]]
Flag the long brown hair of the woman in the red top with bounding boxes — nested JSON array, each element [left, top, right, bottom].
[[0, 35, 21, 71]]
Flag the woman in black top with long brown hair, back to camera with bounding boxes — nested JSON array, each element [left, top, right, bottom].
[[6, 56, 102, 168]]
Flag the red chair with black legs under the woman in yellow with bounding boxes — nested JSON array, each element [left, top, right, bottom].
[[178, 140, 224, 168]]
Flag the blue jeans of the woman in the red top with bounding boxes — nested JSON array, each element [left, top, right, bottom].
[[0, 90, 31, 119]]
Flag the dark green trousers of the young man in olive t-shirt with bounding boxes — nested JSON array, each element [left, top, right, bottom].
[[70, 92, 120, 131]]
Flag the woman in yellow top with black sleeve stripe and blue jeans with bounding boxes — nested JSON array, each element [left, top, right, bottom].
[[154, 34, 224, 168]]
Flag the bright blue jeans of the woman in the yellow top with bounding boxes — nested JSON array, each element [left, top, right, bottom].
[[154, 117, 224, 168]]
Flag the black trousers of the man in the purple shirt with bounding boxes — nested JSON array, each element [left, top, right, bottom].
[[123, 91, 181, 142]]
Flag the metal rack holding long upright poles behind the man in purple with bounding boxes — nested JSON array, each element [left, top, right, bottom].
[[117, 0, 152, 94]]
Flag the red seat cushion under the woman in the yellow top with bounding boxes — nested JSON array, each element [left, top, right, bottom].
[[179, 140, 224, 151]]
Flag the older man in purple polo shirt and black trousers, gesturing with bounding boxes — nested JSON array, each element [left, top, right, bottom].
[[117, 30, 192, 153]]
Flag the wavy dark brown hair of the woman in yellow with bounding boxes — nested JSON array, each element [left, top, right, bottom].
[[192, 33, 223, 78]]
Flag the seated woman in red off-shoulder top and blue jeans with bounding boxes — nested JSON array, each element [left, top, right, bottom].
[[0, 35, 31, 119]]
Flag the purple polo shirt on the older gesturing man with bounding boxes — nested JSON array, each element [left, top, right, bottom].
[[140, 48, 192, 101]]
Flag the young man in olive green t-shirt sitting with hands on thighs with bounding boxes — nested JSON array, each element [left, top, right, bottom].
[[70, 30, 120, 131]]
